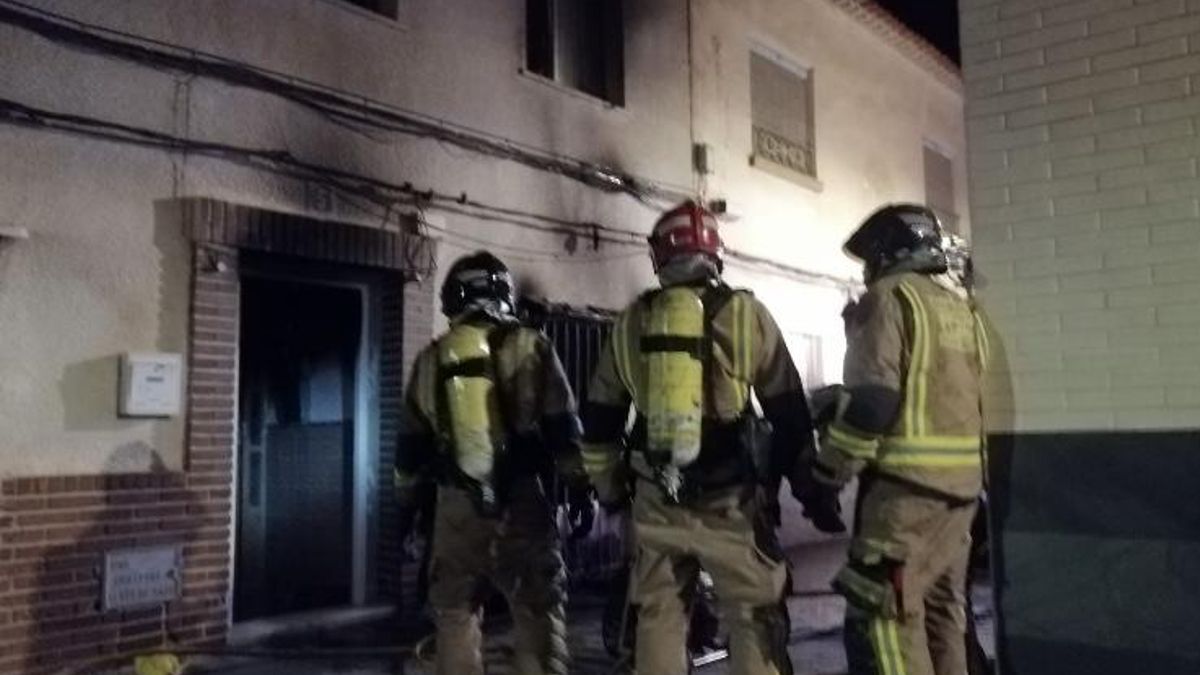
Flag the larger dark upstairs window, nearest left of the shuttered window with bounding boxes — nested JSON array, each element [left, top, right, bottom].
[[526, 0, 625, 106]]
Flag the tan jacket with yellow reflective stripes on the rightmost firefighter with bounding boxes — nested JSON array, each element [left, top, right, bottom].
[[815, 271, 988, 500]]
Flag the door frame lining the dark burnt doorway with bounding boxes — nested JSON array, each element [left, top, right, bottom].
[[229, 265, 380, 612]]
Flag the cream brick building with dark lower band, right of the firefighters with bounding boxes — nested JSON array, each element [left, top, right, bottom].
[[959, 0, 1200, 675]]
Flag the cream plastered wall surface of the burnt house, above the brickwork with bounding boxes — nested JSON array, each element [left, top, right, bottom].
[[0, 0, 966, 476]]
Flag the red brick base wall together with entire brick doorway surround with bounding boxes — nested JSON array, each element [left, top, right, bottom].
[[0, 199, 433, 675]]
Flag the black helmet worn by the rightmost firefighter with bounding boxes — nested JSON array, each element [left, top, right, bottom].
[[842, 204, 946, 281]]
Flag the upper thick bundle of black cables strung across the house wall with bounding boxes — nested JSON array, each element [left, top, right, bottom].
[[0, 0, 686, 203]]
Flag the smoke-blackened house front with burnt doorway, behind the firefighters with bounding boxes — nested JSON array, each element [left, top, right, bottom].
[[0, 0, 968, 673]]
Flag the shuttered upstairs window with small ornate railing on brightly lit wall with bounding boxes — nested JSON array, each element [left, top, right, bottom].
[[750, 52, 817, 178]]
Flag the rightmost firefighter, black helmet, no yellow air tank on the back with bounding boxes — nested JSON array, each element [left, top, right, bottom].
[[814, 204, 986, 675]]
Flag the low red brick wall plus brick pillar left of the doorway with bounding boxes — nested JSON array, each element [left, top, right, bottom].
[[0, 246, 238, 674]]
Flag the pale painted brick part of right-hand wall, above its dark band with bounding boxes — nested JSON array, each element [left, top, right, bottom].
[[960, 0, 1200, 430]]
